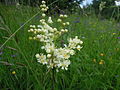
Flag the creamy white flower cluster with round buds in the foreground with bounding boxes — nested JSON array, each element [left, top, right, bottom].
[[28, 1, 83, 70]]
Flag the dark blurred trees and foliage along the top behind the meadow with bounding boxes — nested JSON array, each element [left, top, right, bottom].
[[0, 0, 120, 20]]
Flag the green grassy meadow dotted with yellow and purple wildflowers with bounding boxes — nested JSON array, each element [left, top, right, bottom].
[[0, 2, 120, 90]]
